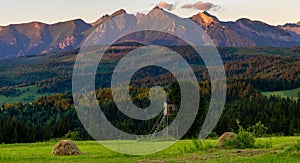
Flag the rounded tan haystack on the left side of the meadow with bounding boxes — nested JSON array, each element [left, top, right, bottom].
[[52, 140, 82, 156]]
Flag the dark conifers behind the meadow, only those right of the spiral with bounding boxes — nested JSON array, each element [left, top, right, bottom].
[[214, 81, 300, 135]]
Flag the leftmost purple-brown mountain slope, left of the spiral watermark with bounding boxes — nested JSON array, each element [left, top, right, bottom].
[[0, 20, 91, 58]]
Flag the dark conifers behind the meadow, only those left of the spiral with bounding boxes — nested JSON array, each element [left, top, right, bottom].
[[0, 94, 90, 143]]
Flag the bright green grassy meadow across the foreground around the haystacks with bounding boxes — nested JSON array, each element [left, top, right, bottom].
[[0, 137, 300, 163]]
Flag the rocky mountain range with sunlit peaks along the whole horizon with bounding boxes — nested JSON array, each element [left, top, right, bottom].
[[0, 7, 300, 58]]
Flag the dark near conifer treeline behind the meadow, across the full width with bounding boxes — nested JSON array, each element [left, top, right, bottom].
[[0, 80, 300, 143]]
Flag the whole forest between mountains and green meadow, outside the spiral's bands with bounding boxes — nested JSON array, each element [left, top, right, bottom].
[[0, 47, 300, 143]]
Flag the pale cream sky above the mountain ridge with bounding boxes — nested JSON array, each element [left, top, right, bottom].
[[0, 0, 300, 26]]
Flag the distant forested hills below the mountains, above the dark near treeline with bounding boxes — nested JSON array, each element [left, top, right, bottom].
[[0, 47, 300, 93]]
